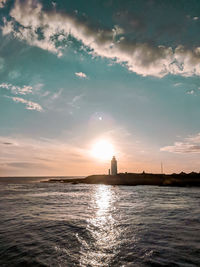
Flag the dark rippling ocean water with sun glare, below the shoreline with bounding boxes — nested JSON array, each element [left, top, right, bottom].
[[0, 179, 200, 267]]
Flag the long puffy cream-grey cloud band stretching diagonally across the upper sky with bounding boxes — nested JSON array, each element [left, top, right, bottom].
[[2, 0, 200, 77]]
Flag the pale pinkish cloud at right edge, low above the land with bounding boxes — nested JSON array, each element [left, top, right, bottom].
[[160, 133, 200, 154]]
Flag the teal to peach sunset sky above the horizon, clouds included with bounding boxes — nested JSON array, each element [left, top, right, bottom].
[[0, 0, 200, 176]]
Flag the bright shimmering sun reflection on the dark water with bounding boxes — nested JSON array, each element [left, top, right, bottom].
[[80, 185, 120, 266]]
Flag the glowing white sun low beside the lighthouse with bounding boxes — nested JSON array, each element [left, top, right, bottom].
[[91, 139, 114, 160]]
